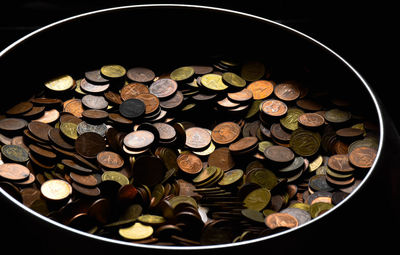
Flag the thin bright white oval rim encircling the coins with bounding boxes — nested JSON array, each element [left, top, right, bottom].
[[0, 4, 385, 250]]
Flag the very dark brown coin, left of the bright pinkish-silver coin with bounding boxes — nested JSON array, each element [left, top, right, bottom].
[[75, 132, 106, 158]]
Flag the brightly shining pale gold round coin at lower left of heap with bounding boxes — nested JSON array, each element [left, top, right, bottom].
[[40, 179, 72, 201]]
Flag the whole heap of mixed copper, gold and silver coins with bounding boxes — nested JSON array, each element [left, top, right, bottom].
[[0, 57, 379, 245]]
